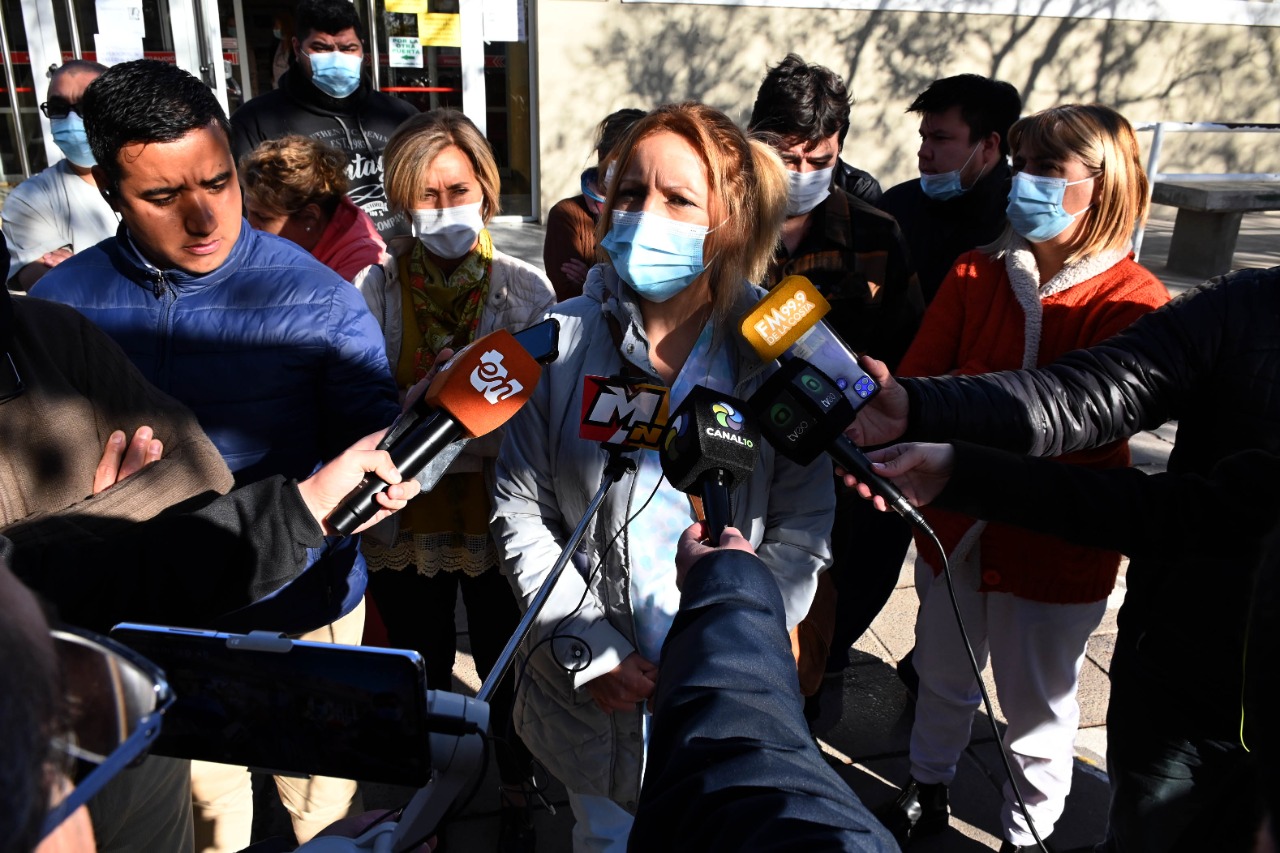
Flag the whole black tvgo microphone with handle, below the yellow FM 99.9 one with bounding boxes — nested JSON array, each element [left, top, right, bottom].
[[749, 359, 929, 529]]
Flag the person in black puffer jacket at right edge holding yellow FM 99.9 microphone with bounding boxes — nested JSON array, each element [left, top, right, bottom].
[[850, 268, 1280, 852]]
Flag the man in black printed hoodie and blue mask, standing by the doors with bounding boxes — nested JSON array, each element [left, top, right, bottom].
[[232, 0, 417, 240]]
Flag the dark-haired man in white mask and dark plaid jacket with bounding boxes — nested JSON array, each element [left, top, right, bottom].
[[750, 54, 924, 716]]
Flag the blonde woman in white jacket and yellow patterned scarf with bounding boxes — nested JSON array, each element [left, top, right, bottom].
[[356, 110, 556, 850]]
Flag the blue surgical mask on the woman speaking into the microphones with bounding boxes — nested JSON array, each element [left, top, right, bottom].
[[600, 210, 709, 302]]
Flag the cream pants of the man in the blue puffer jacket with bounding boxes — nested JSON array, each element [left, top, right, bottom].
[[191, 598, 365, 853]]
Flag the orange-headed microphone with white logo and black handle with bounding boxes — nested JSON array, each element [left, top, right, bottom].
[[328, 329, 543, 535]]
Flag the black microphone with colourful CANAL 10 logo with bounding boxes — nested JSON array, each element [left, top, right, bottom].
[[659, 386, 760, 546]]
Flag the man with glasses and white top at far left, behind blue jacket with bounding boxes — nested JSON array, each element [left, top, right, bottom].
[[4, 59, 118, 291]]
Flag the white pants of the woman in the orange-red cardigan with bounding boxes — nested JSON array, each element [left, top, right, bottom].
[[911, 549, 1107, 845]]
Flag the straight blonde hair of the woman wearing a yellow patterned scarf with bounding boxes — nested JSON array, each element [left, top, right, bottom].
[[383, 109, 502, 224]]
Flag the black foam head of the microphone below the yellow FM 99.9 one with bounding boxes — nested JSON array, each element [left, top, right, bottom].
[[748, 359, 856, 465]]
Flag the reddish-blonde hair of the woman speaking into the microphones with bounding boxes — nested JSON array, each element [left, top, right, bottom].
[[595, 102, 787, 319]]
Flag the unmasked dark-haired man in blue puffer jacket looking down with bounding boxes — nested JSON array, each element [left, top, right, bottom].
[[33, 60, 399, 850]]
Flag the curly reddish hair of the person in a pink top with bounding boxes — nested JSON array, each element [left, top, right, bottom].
[[239, 136, 349, 216]]
